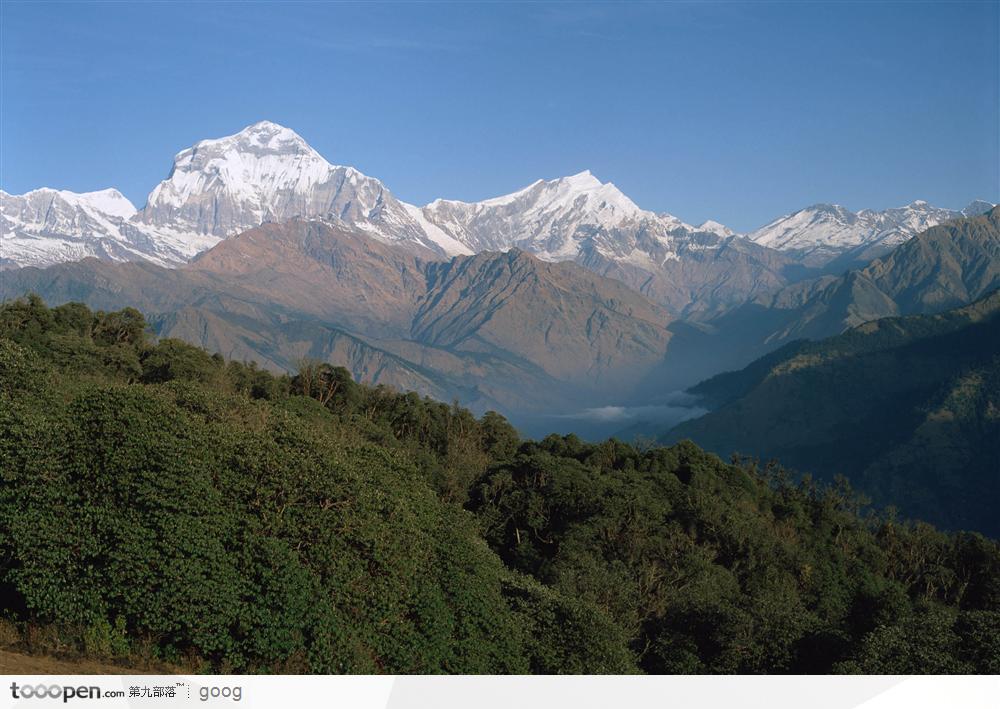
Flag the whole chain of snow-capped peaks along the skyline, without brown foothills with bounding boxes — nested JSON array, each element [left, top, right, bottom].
[[0, 121, 990, 320]]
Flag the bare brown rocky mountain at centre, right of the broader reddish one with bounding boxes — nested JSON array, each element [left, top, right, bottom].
[[411, 249, 669, 389]]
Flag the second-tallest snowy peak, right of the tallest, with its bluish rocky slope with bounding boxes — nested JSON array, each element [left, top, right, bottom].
[[402, 171, 787, 317]]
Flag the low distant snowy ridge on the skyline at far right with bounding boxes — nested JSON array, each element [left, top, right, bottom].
[[748, 200, 993, 267]]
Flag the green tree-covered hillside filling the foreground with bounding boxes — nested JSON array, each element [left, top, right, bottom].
[[0, 298, 1000, 673]]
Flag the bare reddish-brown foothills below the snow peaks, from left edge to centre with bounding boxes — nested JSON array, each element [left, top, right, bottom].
[[0, 220, 670, 411]]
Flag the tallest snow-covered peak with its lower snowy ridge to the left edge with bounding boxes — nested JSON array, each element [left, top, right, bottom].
[[0, 121, 469, 267]]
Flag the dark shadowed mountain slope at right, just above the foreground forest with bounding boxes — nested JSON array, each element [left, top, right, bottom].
[[664, 292, 1000, 535]]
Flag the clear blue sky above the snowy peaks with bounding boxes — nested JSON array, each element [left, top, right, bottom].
[[0, 0, 1000, 229]]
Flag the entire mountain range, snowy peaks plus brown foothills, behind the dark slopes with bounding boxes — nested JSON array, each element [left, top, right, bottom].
[[0, 121, 1000, 436]]
